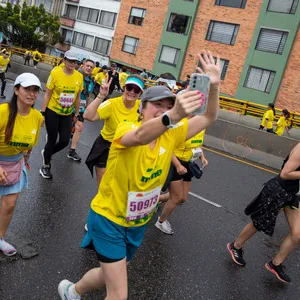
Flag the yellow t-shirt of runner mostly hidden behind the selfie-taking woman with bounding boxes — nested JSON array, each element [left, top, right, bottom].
[[174, 130, 205, 162]]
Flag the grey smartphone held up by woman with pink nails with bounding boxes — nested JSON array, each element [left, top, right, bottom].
[[190, 73, 210, 115]]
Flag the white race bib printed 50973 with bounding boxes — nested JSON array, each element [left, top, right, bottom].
[[126, 186, 161, 221]]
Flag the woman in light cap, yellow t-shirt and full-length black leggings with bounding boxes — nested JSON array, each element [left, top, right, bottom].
[[40, 51, 83, 179]]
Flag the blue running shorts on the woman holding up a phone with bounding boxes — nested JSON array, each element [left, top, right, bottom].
[[81, 209, 147, 263]]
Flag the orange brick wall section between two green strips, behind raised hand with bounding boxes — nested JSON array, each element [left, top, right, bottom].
[[181, 0, 263, 96]]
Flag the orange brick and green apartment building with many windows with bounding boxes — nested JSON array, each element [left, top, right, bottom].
[[111, 0, 300, 111]]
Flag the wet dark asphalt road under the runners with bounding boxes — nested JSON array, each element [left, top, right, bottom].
[[0, 86, 300, 300]]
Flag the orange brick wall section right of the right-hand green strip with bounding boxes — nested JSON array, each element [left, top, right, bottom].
[[275, 30, 300, 112]]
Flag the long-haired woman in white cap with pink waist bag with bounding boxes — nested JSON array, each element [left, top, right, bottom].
[[0, 73, 43, 256]]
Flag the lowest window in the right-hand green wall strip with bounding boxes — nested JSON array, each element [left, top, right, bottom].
[[244, 66, 275, 93]]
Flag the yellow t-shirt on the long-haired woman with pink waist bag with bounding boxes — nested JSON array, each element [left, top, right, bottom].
[[0, 103, 43, 156]]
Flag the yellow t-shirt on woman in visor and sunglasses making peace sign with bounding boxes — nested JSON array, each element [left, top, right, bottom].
[[97, 96, 140, 142]]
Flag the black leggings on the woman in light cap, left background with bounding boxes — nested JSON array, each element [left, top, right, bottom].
[[44, 108, 72, 165]]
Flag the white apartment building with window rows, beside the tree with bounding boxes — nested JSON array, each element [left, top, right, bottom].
[[60, 0, 120, 65]]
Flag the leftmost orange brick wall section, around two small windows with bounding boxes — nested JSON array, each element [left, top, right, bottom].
[[110, 0, 169, 70]]
